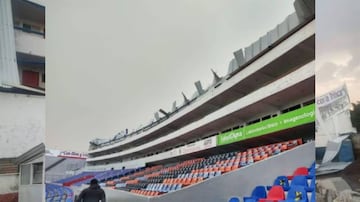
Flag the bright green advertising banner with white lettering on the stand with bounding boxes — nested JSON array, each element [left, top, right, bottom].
[[217, 104, 315, 146]]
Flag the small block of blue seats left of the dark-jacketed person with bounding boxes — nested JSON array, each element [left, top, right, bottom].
[[45, 183, 74, 202]]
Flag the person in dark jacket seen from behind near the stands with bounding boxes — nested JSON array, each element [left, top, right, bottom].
[[77, 179, 106, 202]]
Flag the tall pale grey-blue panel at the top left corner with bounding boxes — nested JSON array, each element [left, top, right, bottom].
[[0, 0, 20, 86]]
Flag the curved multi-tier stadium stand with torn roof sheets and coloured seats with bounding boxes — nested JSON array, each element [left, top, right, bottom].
[[46, 0, 315, 202]]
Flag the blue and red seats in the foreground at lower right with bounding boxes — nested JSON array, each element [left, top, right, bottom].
[[238, 163, 316, 202]]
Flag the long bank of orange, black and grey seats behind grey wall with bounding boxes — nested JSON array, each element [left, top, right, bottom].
[[106, 139, 302, 194]]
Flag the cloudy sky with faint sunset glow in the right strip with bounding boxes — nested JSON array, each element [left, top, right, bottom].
[[316, 0, 360, 103]]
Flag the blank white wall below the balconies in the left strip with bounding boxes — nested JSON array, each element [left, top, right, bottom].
[[0, 92, 45, 158]]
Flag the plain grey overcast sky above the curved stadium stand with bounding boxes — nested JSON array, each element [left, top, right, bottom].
[[46, 0, 294, 152]]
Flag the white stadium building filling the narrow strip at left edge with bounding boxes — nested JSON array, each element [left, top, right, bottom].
[[0, 0, 45, 202]]
